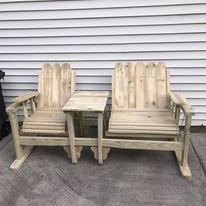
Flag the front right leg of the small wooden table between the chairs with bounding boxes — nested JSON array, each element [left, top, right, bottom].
[[98, 113, 103, 164]]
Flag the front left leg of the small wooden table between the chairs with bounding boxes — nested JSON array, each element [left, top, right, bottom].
[[67, 112, 77, 164]]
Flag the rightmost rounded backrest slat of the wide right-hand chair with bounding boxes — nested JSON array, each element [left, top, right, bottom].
[[156, 62, 167, 108]]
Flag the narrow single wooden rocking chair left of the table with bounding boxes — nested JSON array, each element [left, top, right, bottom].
[[7, 63, 81, 169]]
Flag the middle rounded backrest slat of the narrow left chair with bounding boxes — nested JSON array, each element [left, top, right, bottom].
[[52, 64, 61, 108]]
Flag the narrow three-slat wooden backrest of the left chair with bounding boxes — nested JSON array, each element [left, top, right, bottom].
[[38, 63, 75, 109]]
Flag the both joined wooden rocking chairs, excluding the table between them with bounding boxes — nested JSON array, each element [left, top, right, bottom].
[[7, 62, 194, 178]]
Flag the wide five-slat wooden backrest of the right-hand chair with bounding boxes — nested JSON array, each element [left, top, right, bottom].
[[112, 62, 170, 110]]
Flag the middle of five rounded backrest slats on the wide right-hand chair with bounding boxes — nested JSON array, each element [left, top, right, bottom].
[[135, 62, 146, 109]]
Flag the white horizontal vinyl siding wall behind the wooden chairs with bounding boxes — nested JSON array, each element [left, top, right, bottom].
[[0, 0, 206, 125]]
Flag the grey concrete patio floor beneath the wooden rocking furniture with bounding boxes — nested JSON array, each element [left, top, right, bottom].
[[0, 133, 206, 206]]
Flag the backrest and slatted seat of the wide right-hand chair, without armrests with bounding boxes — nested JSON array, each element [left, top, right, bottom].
[[108, 62, 179, 136]]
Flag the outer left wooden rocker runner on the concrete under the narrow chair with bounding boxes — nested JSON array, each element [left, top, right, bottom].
[[10, 146, 33, 170]]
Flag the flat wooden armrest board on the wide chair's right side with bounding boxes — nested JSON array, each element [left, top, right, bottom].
[[169, 92, 195, 115]]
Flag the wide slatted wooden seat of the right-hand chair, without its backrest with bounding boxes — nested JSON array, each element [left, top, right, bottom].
[[108, 110, 179, 136]]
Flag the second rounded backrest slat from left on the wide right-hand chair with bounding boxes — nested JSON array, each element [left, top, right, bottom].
[[128, 63, 136, 108]]
